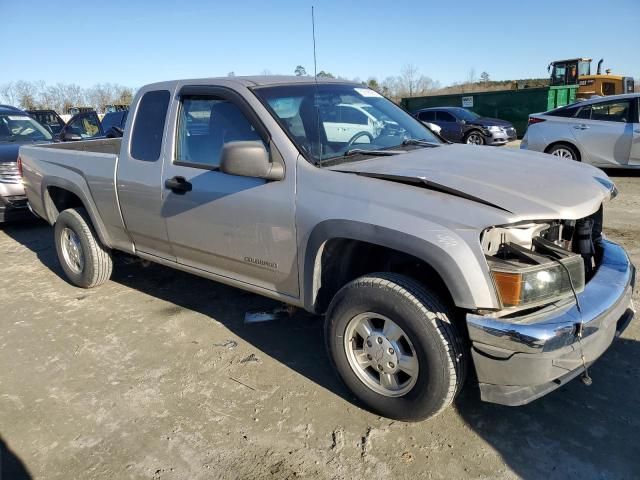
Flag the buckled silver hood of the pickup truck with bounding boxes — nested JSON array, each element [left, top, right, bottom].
[[330, 144, 615, 221]]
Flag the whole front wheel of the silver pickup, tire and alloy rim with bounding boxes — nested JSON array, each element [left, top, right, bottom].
[[325, 273, 467, 421]]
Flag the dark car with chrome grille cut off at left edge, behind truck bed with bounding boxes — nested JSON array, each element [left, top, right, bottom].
[[0, 105, 53, 222]]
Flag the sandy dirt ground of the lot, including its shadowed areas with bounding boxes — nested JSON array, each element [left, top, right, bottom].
[[0, 171, 640, 480]]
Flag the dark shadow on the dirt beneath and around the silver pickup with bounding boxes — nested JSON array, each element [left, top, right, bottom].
[[3, 224, 640, 479]]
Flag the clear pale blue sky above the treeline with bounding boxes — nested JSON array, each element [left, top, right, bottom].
[[0, 0, 640, 87]]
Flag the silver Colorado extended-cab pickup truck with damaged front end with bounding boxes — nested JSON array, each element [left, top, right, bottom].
[[20, 77, 635, 420]]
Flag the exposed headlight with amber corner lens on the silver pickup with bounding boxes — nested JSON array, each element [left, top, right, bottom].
[[487, 241, 585, 308]]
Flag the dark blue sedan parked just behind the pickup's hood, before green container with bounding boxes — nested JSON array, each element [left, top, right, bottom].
[[415, 107, 517, 145]]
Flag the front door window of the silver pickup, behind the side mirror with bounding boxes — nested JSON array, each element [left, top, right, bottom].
[[176, 95, 261, 169]]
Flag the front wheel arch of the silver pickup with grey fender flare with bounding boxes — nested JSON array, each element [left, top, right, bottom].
[[302, 220, 476, 313]]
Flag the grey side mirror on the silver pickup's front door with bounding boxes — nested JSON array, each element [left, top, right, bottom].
[[220, 141, 284, 180]]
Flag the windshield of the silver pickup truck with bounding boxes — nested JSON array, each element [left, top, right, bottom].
[[254, 83, 442, 163]]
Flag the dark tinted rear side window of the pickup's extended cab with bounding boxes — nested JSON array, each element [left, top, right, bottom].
[[131, 90, 171, 162]]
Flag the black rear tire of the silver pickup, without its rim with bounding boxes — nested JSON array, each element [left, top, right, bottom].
[[54, 208, 113, 288]]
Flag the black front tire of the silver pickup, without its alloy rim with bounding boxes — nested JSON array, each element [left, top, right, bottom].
[[325, 273, 468, 421]]
